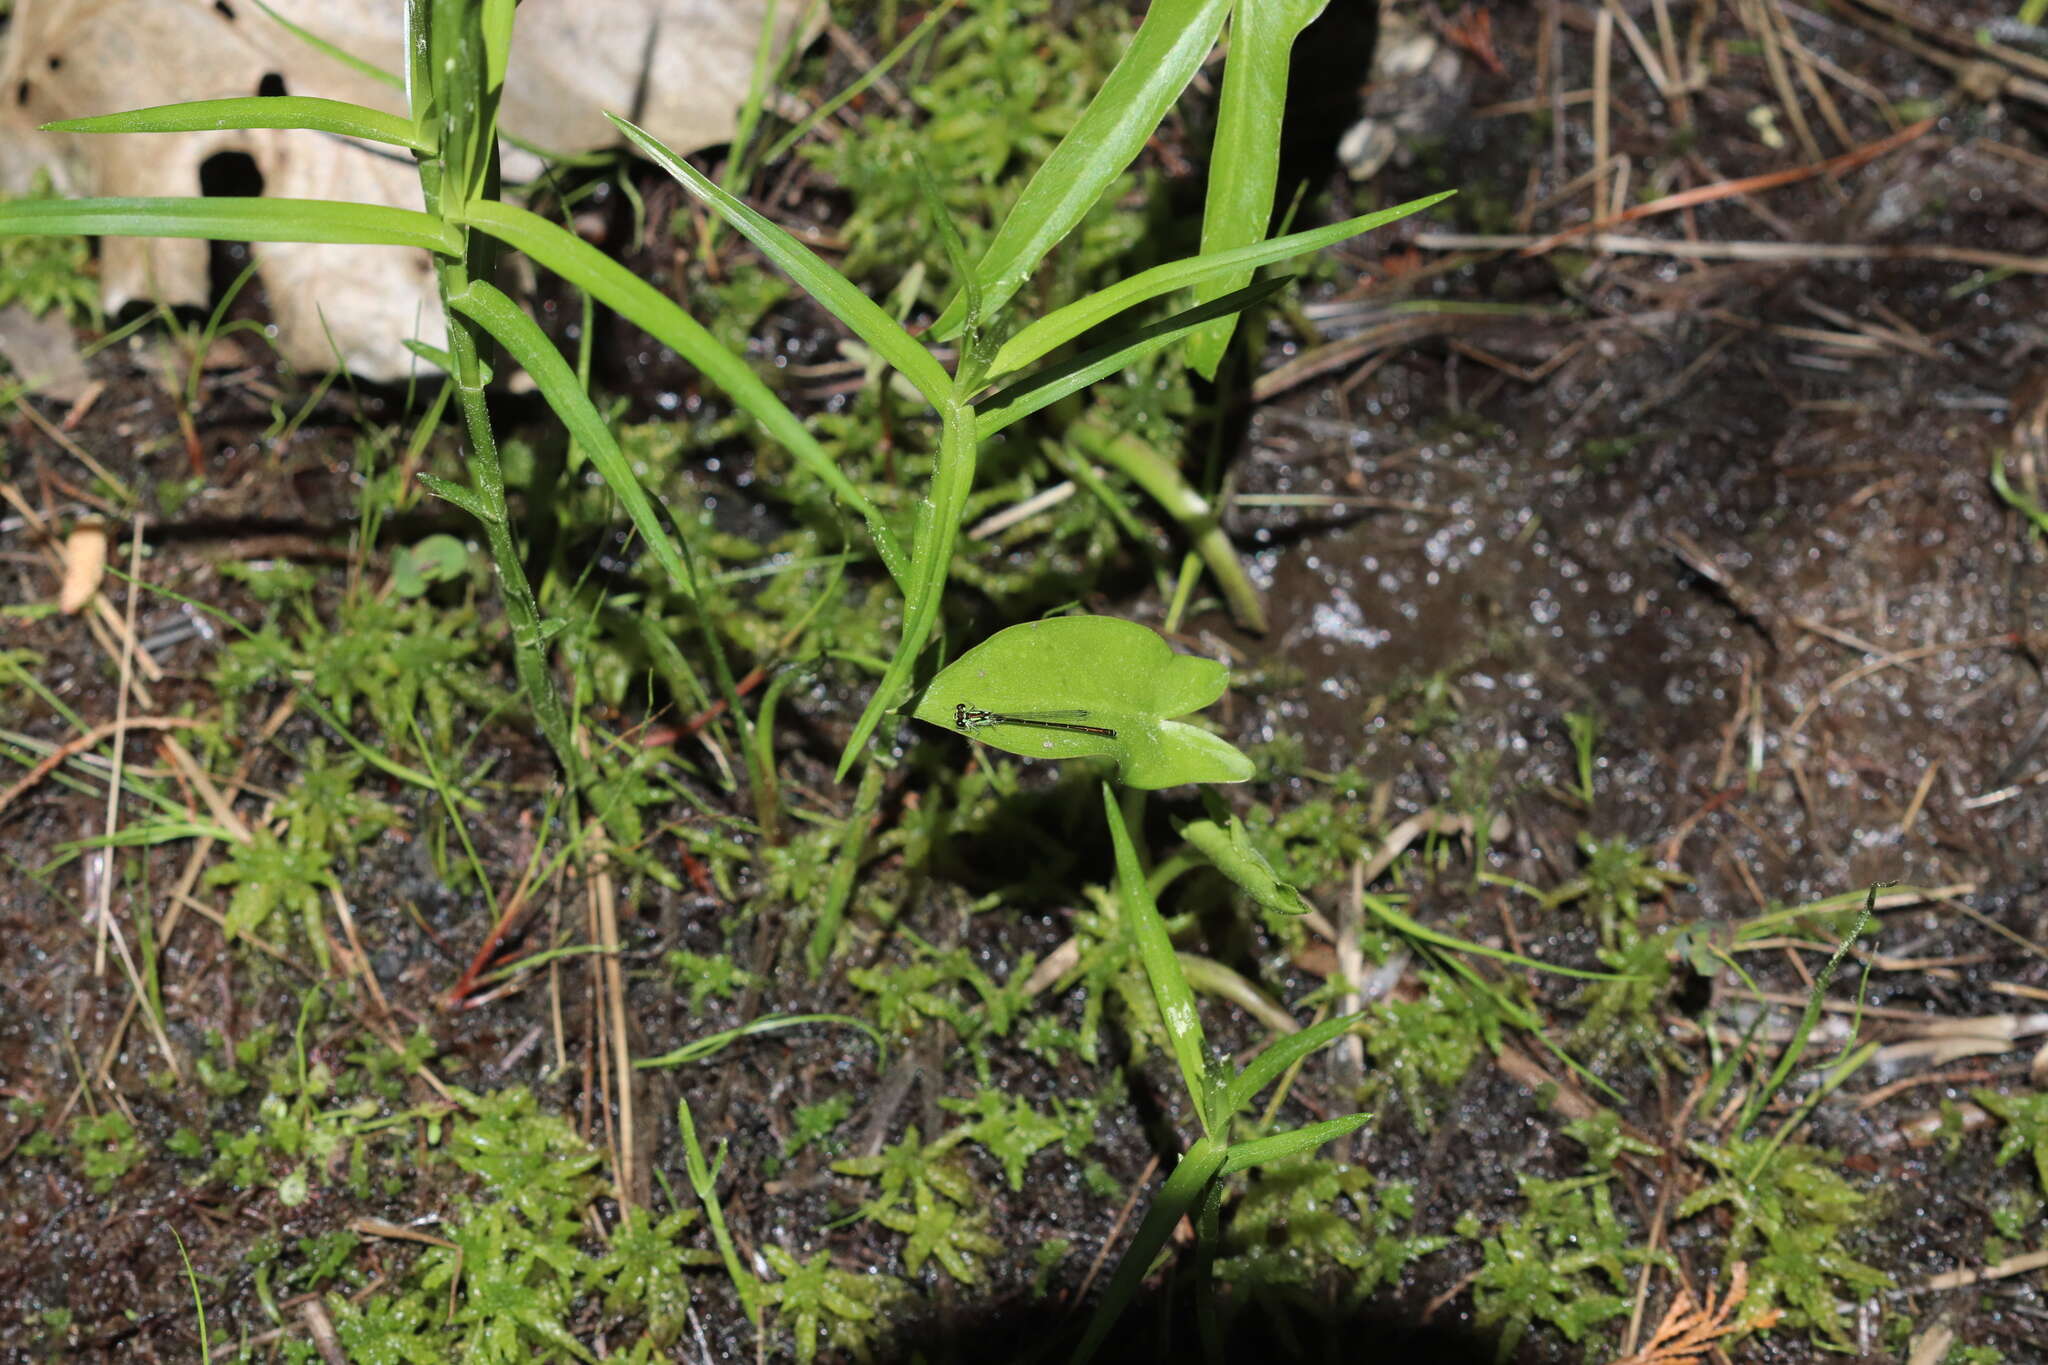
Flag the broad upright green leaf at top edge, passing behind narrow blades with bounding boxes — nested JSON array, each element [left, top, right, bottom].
[[1188, 0, 1325, 379]]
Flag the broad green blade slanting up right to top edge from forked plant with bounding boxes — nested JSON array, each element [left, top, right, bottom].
[[932, 0, 1231, 338]]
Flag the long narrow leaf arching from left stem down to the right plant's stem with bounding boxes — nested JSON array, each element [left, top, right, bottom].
[[463, 199, 909, 585]]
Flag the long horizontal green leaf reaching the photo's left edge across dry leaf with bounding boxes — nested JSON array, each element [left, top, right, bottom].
[[0, 196, 463, 256]]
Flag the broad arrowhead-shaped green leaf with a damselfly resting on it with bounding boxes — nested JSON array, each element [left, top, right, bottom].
[[911, 616, 1251, 788]]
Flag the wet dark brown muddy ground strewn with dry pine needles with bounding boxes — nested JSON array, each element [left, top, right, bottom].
[[0, 0, 2048, 1363]]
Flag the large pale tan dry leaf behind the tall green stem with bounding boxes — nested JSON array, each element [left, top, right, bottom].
[[0, 0, 811, 379]]
